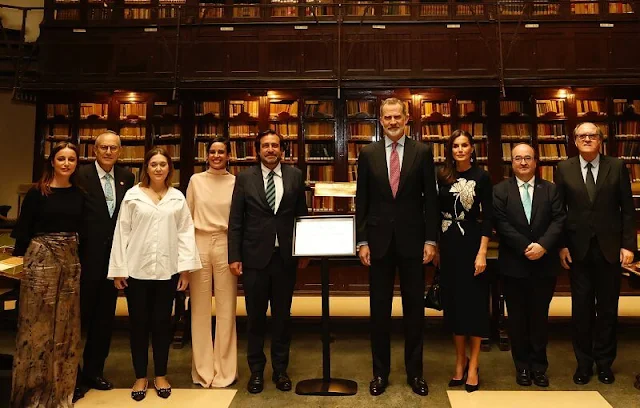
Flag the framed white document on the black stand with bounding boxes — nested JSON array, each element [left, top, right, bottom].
[[293, 215, 356, 257]]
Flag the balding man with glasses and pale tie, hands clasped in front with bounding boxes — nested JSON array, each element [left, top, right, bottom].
[[493, 143, 566, 387]]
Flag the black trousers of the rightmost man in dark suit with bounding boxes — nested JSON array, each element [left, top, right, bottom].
[[569, 237, 621, 373]]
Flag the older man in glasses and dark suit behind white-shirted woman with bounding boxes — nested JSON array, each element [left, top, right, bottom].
[[74, 131, 134, 400]]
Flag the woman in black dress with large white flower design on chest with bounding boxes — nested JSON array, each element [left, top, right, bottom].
[[438, 130, 492, 392]]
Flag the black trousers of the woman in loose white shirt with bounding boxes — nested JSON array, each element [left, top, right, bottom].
[[125, 274, 180, 378]]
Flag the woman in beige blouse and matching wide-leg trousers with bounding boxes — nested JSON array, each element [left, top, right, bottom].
[[187, 137, 238, 388]]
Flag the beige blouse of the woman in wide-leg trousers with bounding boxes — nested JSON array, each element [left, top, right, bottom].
[[187, 169, 236, 233]]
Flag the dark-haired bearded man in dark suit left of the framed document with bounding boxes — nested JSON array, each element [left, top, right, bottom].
[[228, 130, 308, 394]]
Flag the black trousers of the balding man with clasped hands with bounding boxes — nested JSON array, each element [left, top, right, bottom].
[[502, 276, 557, 372]]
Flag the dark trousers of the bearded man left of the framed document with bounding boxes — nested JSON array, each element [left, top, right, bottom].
[[242, 251, 296, 374]]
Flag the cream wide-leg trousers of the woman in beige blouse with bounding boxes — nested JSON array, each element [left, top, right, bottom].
[[189, 231, 238, 388]]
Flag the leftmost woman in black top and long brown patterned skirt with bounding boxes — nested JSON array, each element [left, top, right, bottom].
[[11, 142, 83, 408]]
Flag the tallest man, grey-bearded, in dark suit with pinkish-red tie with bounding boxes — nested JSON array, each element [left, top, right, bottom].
[[356, 98, 440, 396]]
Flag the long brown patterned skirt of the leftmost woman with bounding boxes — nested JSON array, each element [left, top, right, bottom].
[[11, 233, 81, 408]]
